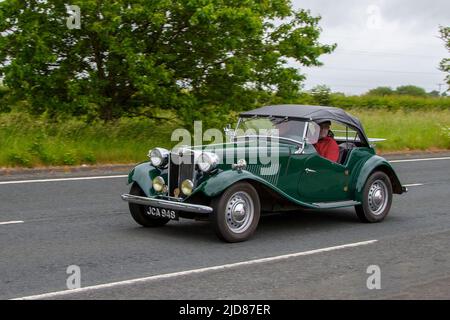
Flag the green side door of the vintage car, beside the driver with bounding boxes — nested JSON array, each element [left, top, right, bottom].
[[294, 144, 350, 202]]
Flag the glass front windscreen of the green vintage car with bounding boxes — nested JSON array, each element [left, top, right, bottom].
[[236, 117, 306, 141]]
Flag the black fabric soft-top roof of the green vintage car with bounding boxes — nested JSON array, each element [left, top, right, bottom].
[[240, 104, 367, 141]]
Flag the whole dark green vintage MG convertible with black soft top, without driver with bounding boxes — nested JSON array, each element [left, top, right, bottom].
[[122, 105, 407, 242]]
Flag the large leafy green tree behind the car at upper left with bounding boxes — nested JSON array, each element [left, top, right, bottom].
[[0, 0, 335, 120]]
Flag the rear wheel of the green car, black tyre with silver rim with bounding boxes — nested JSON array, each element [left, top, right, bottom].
[[355, 171, 392, 223]]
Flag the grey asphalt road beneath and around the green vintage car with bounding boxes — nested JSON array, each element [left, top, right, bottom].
[[0, 155, 450, 299]]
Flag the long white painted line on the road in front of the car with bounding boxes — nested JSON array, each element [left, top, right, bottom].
[[12, 240, 378, 300]]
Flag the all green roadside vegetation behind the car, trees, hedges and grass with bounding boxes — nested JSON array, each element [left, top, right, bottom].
[[0, 0, 450, 167]]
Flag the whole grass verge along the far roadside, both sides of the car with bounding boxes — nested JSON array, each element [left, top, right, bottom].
[[0, 109, 450, 167]]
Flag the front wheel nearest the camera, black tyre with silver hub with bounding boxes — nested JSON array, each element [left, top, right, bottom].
[[211, 182, 261, 242]]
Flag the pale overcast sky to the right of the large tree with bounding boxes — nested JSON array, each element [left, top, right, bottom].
[[292, 0, 450, 94]]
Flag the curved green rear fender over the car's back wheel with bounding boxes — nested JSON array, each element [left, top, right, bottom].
[[355, 156, 404, 202]]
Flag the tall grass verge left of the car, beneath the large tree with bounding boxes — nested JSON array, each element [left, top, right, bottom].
[[0, 113, 176, 167]]
